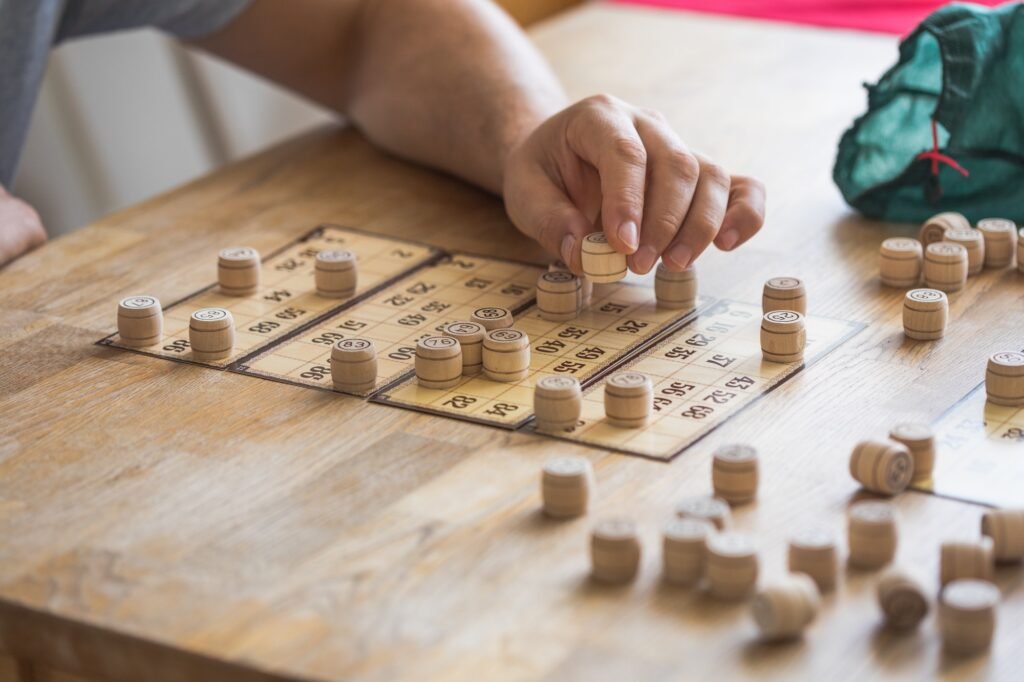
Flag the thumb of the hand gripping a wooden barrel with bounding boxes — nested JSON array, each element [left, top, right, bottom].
[[506, 169, 594, 274]]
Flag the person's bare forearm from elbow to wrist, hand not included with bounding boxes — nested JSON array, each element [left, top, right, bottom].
[[347, 0, 565, 193]]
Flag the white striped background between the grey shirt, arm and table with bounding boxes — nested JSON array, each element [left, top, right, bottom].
[[13, 31, 332, 236]]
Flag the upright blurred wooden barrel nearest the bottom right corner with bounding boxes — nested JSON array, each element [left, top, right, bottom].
[[939, 580, 999, 656]]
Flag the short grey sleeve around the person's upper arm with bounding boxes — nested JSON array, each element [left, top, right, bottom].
[[55, 0, 251, 42]]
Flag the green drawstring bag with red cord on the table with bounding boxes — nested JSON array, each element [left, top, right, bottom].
[[833, 2, 1024, 222]]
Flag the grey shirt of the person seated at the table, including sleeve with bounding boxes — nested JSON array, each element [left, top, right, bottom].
[[0, 0, 250, 186]]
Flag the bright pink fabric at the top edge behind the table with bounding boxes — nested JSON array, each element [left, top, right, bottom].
[[614, 0, 1005, 35]]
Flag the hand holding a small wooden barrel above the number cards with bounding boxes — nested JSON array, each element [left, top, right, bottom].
[[504, 95, 765, 274]]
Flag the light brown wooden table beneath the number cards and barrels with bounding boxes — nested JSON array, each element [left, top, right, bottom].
[[0, 4, 1024, 681]]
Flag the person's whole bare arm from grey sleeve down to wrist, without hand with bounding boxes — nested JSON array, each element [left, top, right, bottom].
[[196, 0, 565, 191]]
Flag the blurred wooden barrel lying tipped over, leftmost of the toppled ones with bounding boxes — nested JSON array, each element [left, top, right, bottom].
[[751, 573, 821, 642]]
